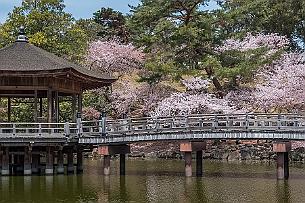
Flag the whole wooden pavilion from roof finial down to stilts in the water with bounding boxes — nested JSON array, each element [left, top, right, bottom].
[[0, 28, 116, 175]]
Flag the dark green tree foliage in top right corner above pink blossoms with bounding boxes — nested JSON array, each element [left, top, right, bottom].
[[217, 0, 305, 49]]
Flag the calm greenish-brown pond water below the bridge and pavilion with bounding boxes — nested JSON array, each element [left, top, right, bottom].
[[0, 160, 305, 203]]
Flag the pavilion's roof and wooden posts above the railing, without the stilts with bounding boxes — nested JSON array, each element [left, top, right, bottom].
[[0, 28, 115, 123]]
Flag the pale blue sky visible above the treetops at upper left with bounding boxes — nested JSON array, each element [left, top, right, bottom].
[[0, 0, 216, 23]]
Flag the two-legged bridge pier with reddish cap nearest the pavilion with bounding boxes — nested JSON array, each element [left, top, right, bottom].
[[98, 145, 130, 175]]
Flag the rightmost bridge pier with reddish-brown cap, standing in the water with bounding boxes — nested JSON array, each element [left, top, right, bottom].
[[273, 142, 291, 180]]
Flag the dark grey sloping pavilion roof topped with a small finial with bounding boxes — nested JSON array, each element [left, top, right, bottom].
[[0, 28, 116, 89]]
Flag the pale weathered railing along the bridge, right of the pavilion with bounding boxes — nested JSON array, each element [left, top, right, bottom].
[[88, 114, 305, 135]]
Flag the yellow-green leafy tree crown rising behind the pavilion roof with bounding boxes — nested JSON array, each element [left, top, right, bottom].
[[0, 0, 88, 62]]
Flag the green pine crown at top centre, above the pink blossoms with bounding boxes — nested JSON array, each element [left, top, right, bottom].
[[127, 0, 215, 82]]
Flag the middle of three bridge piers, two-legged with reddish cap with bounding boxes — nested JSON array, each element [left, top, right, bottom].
[[180, 142, 206, 177]]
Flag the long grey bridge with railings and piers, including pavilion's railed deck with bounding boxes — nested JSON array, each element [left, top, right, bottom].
[[0, 113, 305, 179]]
